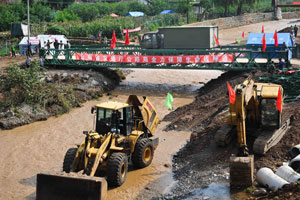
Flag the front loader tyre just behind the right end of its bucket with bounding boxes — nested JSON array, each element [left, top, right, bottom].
[[107, 153, 128, 187]]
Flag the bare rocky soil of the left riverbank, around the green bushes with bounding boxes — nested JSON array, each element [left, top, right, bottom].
[[0, 69, 120, 130]]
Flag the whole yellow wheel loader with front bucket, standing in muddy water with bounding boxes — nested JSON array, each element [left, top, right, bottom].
[[37, 95, 159, 199]]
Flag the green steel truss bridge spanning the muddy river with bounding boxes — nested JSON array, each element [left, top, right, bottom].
[[40, 45, 288, 71]]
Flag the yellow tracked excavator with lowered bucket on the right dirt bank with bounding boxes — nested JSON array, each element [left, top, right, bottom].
[[215, 77, 290, 187]]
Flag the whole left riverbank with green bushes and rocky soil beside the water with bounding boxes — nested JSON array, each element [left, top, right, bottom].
[[0, 63, 120, 129]]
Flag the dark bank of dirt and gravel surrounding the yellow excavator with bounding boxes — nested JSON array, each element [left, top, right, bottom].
[[163, 71, 300, 199]]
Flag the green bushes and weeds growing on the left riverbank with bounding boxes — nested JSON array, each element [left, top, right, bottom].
[[0, 62, 79, 113]]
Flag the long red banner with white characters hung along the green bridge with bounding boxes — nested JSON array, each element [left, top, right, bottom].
[[75, 53, 234, 64]]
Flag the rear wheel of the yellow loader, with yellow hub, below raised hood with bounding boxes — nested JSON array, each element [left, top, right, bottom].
[[132, 138, 154, 168]]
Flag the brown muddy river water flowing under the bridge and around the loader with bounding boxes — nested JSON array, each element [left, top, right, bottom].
[[0, 69, 222, 200]]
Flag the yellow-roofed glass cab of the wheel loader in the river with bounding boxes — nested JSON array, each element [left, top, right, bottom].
[[92, 102, 133, 136]]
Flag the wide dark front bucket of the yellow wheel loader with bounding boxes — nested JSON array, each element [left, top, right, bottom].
[[36, 173, 107, 200]]
